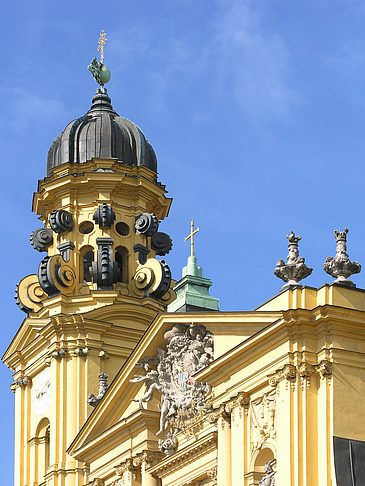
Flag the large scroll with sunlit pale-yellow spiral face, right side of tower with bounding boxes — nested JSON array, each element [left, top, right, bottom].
[[133, 258, 171, 299]]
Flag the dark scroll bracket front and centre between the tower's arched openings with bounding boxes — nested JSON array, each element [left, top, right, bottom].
[[90, 238, 120, 290]]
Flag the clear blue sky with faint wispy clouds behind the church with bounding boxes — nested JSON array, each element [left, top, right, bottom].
[[0, 0, 365, 484]]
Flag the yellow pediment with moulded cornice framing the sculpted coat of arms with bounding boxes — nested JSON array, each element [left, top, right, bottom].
[[68, 312, 278, 462]]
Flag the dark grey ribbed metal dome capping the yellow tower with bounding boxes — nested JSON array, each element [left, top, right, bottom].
[[47, 88, 157, 176]]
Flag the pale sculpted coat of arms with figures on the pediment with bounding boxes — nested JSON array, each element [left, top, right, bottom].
[[131, 324, 213, 454]]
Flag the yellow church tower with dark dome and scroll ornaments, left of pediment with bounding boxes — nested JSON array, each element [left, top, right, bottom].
[[3, 36, 175, 486]]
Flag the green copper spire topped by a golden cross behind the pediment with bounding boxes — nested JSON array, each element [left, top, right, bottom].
[[167, 221, 219, 312]]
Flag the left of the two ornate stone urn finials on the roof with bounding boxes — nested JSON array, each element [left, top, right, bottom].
[[274, 231, 313, 289]]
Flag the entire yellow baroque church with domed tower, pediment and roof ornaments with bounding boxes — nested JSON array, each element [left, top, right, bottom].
[[3, 50, 365, 486]]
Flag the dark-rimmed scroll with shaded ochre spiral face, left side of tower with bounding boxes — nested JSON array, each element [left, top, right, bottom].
[[38, 255, 76, 296]]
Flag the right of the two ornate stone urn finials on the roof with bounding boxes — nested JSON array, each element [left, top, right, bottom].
[[323, 228, 361, 287]]
